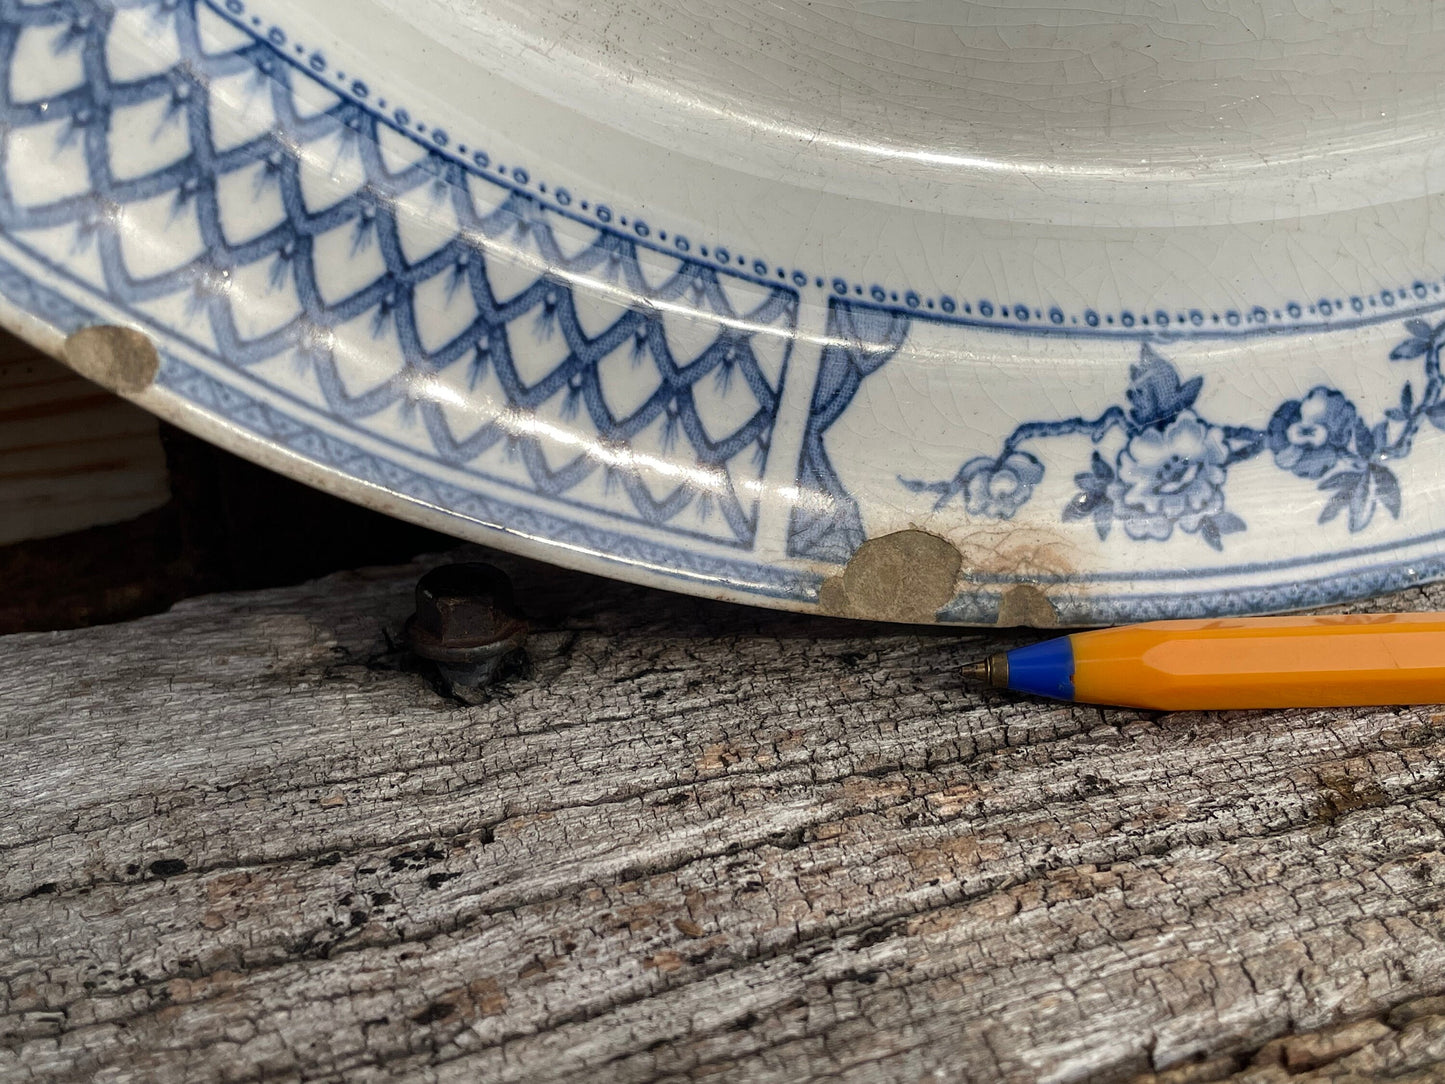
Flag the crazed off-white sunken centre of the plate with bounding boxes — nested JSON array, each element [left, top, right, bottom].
[[398, 0, 1445, 225]]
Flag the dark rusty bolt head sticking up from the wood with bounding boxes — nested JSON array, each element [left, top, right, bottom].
[[406, 564, 527, 663]]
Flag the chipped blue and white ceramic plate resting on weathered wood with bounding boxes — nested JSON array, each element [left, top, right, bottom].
[[0, 0, 1445, 624]]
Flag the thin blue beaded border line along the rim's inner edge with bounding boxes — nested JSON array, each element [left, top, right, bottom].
[[202, 0, 1445, 338]]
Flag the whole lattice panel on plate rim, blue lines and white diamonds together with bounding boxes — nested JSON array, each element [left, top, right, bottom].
[[0, 0, 798, 549]]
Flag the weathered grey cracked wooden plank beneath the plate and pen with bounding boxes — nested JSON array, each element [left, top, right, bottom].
[[0, 562, 1445, 1084]]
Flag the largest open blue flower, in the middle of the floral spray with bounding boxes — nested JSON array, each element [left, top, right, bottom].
[[1108, 410, 1230, 541]]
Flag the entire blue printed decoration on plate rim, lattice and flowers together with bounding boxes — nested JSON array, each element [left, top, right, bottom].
[[0, 0, 1445, 621]]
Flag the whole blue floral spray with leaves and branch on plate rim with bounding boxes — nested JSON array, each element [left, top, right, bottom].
[[899, 319, 1445, 549]]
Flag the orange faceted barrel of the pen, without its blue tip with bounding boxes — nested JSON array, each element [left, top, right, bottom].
[[1069, 614, 1445, 711]]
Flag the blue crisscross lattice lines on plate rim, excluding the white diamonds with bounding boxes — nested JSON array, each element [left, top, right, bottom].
[[0, 0, 798, 546]]
